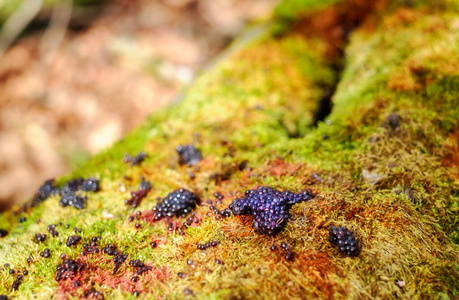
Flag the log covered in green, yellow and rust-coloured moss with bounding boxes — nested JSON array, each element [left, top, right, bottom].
[[0, 0, 459, 299]]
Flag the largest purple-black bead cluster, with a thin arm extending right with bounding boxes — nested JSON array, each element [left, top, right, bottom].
[[229, 187, 314, 235]]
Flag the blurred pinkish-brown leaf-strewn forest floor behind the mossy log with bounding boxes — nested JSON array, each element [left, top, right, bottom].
[[0, 0, 277, 208]]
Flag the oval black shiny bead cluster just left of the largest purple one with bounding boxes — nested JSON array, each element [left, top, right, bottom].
[[153, 188, 199, 220]]
